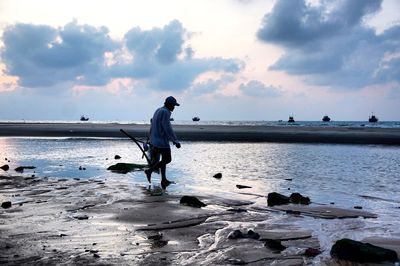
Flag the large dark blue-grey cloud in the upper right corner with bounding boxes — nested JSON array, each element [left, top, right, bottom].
[[257, 0, 400, 88]]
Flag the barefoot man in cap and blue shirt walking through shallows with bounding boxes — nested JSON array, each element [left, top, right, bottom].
[[144, 96, 181, 189]]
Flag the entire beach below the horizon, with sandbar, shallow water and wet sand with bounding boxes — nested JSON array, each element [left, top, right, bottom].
[[0, 123, 400, 265]]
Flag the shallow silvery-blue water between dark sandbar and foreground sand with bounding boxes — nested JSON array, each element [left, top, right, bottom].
[[0, 138, 400, 256]]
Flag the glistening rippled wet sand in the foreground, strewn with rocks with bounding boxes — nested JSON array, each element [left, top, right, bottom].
[[0, 175, 400, 265]]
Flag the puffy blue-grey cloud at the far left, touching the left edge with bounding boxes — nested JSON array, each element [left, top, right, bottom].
[[1, 22, 117, 87]]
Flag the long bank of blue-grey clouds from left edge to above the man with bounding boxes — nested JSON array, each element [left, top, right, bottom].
[[1, 20, 243, 91]]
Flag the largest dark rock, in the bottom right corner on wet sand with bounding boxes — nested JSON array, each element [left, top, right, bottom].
[[330, 238, 398, 262]]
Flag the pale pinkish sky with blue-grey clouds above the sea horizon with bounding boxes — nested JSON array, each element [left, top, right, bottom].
[[0, 0, 400, 121]]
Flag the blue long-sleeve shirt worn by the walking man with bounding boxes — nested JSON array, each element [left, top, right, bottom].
[[150, 106, 179, 148]]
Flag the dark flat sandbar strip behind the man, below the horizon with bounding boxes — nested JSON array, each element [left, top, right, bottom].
[[0, 123, 400, 145]]
